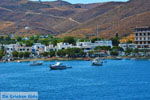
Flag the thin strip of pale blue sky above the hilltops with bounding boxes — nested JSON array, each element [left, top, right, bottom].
[[32, 0, 128, 4]]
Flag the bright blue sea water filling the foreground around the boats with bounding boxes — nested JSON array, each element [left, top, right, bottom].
[[0, 60, 150, 100]]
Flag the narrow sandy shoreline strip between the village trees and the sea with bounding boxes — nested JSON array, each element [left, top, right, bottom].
[[0, 56, 150, 62]]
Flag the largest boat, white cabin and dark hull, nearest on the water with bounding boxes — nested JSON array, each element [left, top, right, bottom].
[[50, 62, 72, 70]]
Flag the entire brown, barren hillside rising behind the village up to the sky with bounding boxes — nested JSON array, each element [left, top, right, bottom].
[[0, 0, 150, 38]]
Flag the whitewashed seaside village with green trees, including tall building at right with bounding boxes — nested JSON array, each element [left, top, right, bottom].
[[0, 27, 150, 61]]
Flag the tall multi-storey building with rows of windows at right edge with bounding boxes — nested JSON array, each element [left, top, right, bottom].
[[134, 27, 150, 49]]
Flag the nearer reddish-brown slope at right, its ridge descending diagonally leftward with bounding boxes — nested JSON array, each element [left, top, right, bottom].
[[65, 0, 150, 38]]
